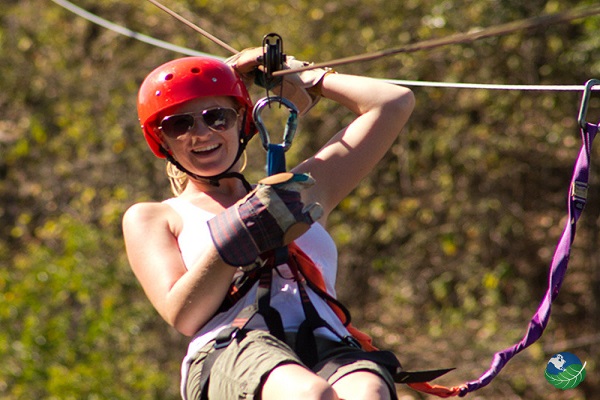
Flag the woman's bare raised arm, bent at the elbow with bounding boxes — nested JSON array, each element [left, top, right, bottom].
[[293, 74, 414, 215]]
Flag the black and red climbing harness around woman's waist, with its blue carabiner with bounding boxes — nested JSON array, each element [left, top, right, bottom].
[[195, 97, 451, 399]]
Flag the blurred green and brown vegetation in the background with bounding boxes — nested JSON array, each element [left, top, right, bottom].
[[0, 0, 600, 400]]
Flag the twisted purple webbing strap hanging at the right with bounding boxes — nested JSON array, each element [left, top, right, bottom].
[[460, 122, 600, 397]]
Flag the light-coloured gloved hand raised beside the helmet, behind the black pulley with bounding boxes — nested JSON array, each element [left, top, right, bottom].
[[225, 47, 333, 116]]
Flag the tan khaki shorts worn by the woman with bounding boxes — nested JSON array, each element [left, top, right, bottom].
[[186, 330, 396, 400]]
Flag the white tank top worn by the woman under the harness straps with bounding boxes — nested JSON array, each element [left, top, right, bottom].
[[164, 198, 348, 399]]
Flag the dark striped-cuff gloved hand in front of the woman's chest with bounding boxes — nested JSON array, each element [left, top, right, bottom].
[[208, 172, 323, 267]]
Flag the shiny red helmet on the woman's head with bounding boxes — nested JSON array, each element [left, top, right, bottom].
[[138, 57, 256, 158]]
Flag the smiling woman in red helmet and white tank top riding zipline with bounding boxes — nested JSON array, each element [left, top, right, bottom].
[[123, 49, 414, 400]]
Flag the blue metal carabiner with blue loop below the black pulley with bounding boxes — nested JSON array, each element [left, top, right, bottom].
[[252, 96, 298, 175]]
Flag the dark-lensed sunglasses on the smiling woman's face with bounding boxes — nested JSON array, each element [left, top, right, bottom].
[[158, 107, 238, 139]]
